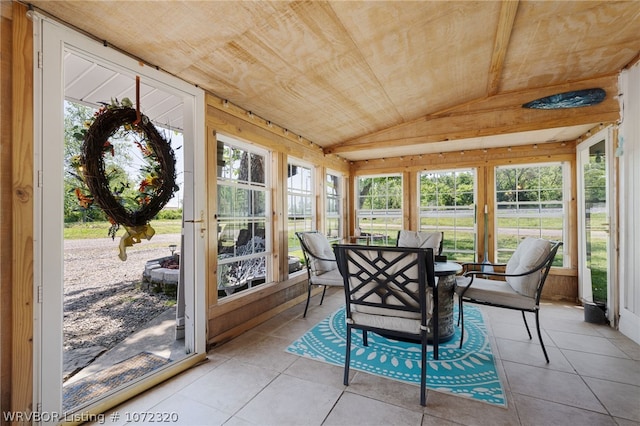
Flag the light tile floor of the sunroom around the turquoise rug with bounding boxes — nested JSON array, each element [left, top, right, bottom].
[[92, 289, 640, 426]]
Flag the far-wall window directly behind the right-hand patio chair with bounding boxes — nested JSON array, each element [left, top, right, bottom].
[[495, 163, 569, 266]]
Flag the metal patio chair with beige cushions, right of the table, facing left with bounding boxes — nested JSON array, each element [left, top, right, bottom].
[[456, 237, 562, 363]]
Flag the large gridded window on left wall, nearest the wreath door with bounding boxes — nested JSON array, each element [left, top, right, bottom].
[[218, 136, 271, 297]]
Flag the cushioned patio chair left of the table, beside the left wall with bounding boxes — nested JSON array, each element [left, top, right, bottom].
[[296, 231, 343, 317]]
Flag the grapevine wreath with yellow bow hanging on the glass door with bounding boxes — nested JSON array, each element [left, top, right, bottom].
[[80, 98, 178, 261]]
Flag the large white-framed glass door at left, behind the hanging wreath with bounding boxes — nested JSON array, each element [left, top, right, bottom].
[[34, 17, 206, 423]]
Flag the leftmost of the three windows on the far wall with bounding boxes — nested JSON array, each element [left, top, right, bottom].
[[356, 175, 402, 245]]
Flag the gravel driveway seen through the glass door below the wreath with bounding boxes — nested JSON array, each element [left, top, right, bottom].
[[63, 234, 180, 351]]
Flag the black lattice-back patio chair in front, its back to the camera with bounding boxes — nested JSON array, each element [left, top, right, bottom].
[[334, 244, 438, 405]]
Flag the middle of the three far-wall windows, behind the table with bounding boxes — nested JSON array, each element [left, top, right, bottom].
[[418, 169, 476, 262]]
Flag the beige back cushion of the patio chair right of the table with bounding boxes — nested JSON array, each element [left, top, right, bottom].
[[504, 237, 551, 297]]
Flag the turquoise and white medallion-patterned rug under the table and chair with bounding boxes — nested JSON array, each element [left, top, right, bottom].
[[286, 306, 507, 407]]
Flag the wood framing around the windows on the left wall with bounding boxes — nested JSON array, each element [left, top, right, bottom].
[[206, 95, 349, 345]]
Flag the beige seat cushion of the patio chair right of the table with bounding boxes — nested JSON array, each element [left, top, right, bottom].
[[456, 277, 536, 310]]
